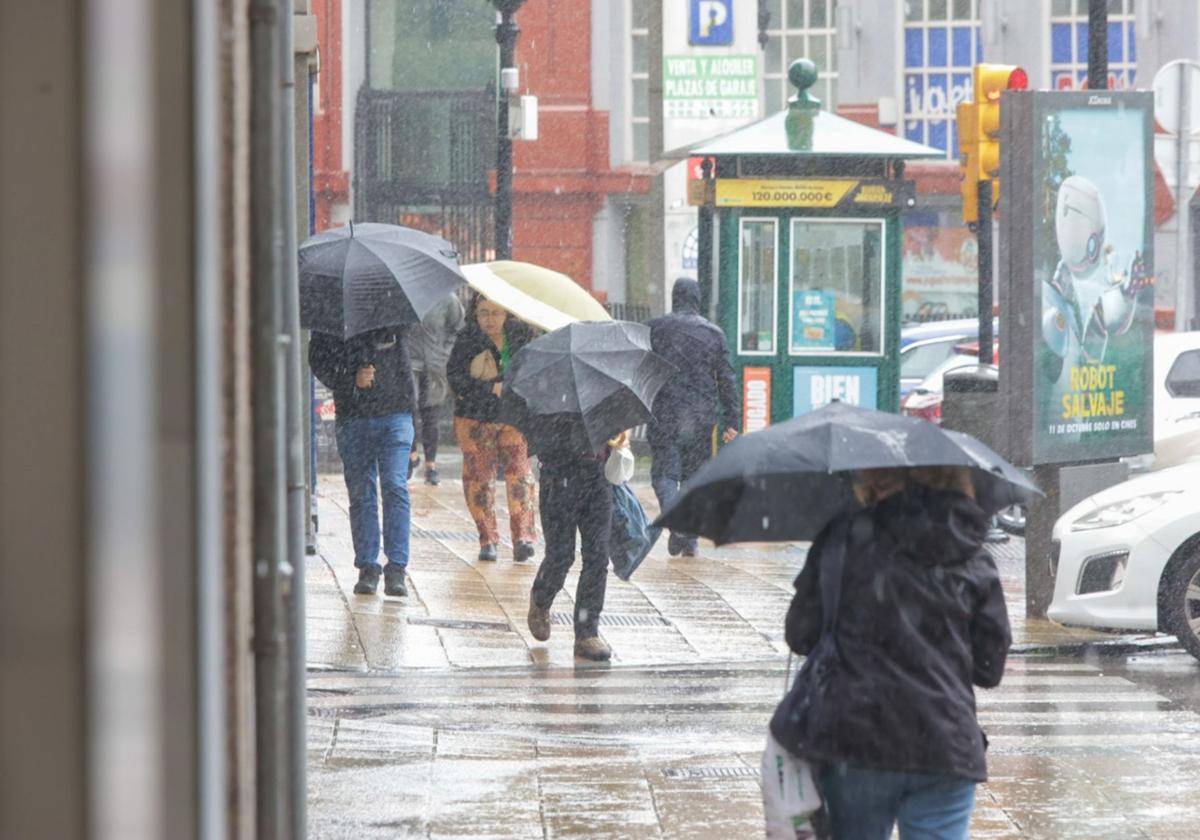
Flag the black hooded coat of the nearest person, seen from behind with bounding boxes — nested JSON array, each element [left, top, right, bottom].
[[772, 487, 1012, 781]]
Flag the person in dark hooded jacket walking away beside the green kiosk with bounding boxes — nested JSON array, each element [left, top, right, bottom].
[[648, 277, 742, 557]]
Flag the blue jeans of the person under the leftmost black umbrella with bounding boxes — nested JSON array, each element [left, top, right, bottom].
[[336, 414, 413, 569]]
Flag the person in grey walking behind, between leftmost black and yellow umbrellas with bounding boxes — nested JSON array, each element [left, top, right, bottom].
[[408, 295, 463, 487]]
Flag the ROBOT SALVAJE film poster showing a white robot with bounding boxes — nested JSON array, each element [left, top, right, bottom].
[[1032, 92, 1154, 463]]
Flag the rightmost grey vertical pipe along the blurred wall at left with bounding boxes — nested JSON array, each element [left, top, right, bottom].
[[277, 0, 308, 838]]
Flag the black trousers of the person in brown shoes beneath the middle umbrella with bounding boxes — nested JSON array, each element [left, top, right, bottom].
[[533, 461, 612, 638]]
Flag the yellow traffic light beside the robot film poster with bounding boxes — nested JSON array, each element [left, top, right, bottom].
[[955, 64, 1030, 223]]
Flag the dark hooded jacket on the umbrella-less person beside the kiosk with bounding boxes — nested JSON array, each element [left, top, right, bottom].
[[649, 278, 742, 436]]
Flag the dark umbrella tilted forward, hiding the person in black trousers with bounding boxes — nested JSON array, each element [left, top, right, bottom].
[[500, 320, 674, 450]]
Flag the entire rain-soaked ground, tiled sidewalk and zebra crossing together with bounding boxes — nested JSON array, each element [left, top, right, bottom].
[[306, 481, 1200, 840]]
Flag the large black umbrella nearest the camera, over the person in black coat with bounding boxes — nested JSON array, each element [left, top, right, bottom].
[[654, 402, 1040, 545]]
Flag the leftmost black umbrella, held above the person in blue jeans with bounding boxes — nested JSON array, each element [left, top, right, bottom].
[[300, 224, 467, 338]]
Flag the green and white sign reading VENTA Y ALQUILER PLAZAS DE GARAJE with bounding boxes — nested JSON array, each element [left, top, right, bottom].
[[662, 54, 758, 120]]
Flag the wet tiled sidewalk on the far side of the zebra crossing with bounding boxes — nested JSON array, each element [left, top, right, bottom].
[[307, 460, 1139, 671]]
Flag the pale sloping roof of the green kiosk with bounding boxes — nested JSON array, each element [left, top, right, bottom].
[[688, 108, 946, 160]]
